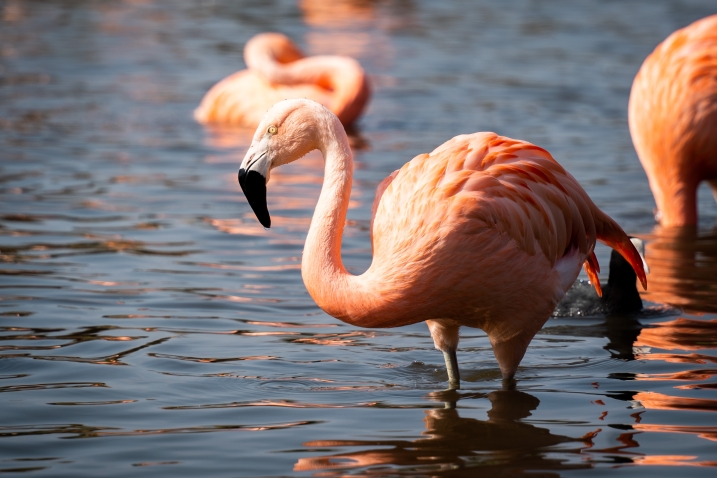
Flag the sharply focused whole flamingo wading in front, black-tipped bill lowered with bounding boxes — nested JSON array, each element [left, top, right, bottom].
[[239, 100, 646, 389]]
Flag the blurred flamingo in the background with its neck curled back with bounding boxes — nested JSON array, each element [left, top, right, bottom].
[[194, 33, 371, 127]]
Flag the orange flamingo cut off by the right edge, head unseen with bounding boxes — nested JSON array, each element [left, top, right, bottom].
[[628, 15, 717, 227]]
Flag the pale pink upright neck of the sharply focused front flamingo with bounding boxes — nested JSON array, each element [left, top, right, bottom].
[[301, 115, 360, 323]]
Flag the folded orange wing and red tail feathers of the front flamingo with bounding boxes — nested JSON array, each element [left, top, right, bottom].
[[372, 133, 644, 296]]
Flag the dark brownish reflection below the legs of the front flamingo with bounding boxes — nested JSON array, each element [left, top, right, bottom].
[[294, 390, 595, 476]]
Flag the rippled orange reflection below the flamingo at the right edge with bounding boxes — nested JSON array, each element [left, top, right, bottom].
[[543, 227, 717, 467]]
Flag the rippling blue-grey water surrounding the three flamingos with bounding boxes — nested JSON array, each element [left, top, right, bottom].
[[0, 0, 717, 476]]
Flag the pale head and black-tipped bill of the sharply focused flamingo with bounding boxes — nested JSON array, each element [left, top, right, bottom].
[[239, 100, 330, 228]]
